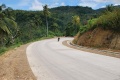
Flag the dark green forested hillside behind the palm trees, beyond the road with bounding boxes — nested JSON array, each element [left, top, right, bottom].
[[1, 5, 96, 45]]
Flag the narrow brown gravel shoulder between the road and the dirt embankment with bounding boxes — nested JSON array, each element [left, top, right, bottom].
[[63, 41, 120, 58]]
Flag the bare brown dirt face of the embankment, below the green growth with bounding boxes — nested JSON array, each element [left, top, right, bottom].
[[73, 28, 120, 50]]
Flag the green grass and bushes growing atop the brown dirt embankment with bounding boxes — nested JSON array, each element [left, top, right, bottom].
[[80, 6, 120, 33]]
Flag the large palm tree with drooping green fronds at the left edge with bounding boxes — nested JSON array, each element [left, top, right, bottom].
[[0, 4, 18, 45]]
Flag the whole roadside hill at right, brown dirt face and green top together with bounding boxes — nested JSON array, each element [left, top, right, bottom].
[[73, 5, 120, 50]]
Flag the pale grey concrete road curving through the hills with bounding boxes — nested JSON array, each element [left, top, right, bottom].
[[26, 38, 120, 80]]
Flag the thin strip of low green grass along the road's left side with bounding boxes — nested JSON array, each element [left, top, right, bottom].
[[0, 36, 54, 56]]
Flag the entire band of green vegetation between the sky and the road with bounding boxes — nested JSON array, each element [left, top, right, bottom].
[[0, 4, 120, 53]]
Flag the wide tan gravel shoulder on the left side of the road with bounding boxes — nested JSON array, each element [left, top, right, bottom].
[[0, 44, 36, 80]]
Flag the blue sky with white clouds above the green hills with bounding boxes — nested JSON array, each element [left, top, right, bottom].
[[0, 0, 120, 10]]
